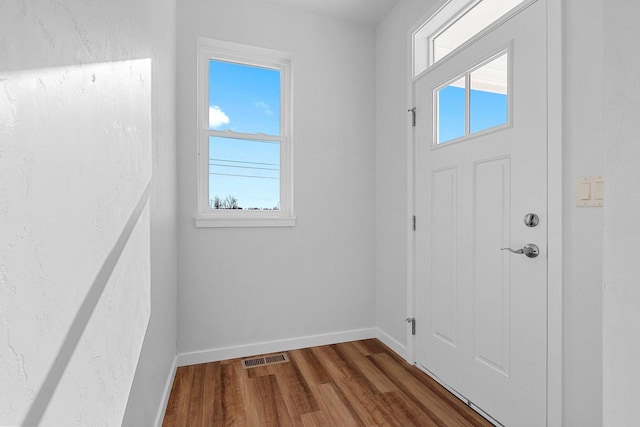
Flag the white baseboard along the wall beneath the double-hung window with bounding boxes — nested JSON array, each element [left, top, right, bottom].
[[178, 328, 378, 366]]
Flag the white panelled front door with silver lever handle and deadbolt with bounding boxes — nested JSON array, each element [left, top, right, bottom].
[[414, 0, 547, 427]]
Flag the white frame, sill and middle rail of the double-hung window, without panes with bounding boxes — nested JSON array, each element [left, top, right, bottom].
[[195, 37, 295, 227]]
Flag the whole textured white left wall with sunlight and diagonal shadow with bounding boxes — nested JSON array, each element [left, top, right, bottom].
[[0, 0, 176, 425]]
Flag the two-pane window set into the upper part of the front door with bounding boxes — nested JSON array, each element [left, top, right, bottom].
[[434, 51, 509, 144]]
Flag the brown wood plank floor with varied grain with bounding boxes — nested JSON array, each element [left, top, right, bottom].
[[163, 340, 491, 427]]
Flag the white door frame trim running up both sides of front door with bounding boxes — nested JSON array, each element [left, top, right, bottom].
[[405, 0, 563, 427]]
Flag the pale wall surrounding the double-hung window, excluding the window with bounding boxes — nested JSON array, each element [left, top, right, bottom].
[[177, 0, 376, 360]]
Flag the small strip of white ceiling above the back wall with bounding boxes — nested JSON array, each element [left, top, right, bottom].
[[262, 0, 400, 25]]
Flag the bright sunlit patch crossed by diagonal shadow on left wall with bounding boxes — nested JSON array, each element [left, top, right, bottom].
[[0, 59, 152, 426]]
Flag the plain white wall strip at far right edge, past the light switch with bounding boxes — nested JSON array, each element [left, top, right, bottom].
[[603, 0, 640, 427]]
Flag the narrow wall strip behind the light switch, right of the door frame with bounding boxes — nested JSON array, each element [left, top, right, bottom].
[[563, 0, 609, 427]]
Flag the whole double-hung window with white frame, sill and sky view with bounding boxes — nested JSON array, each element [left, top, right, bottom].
[[196, 38, 295, 227]]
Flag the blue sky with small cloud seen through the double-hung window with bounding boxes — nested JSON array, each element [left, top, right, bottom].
[[209, 60, 280, 209]]
